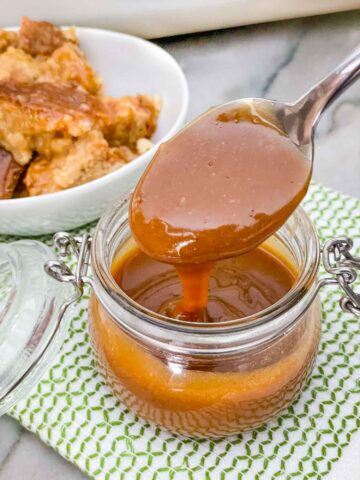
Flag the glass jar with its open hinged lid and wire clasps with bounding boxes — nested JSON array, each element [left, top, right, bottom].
[[0, 198, 360, 437]]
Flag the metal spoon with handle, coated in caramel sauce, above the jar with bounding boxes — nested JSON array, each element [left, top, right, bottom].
[[130, 46, 360, 264]]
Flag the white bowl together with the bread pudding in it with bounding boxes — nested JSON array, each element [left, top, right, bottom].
[[0, 21, 188, 235]]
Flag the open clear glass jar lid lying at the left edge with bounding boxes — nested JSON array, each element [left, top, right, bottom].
[[0, 240, 72, 415]]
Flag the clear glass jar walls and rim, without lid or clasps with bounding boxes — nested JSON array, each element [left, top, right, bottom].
[[90, 197, 321, 437]]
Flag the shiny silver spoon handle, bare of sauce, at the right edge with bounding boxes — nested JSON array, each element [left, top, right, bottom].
[[292, 45, 360, 143]]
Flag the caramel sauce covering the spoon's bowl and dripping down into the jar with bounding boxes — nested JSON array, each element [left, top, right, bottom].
[[129, 101, 311, 320]]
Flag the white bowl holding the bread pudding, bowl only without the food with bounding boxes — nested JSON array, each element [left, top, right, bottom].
[[0, 28, 189, 235]]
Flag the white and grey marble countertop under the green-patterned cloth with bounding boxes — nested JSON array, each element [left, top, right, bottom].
[[0, 11, 360, 480]]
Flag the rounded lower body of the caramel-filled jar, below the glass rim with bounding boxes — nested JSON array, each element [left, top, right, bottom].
[[90, 295, 320, 437]]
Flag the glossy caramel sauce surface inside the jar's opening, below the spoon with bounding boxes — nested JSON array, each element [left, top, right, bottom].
[[112, 241, 296, 322]]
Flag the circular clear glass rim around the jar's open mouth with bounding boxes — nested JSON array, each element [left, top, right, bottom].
[[91, 195, 320, 335]]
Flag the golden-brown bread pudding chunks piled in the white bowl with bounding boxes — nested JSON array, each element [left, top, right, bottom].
[[0, 17, 160, 198]]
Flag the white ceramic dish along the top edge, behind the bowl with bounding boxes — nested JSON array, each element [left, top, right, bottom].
[[1, 0, 359, 38]]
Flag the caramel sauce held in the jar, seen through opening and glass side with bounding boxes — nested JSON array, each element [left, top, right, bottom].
[[90, 231, 320, 438]]
